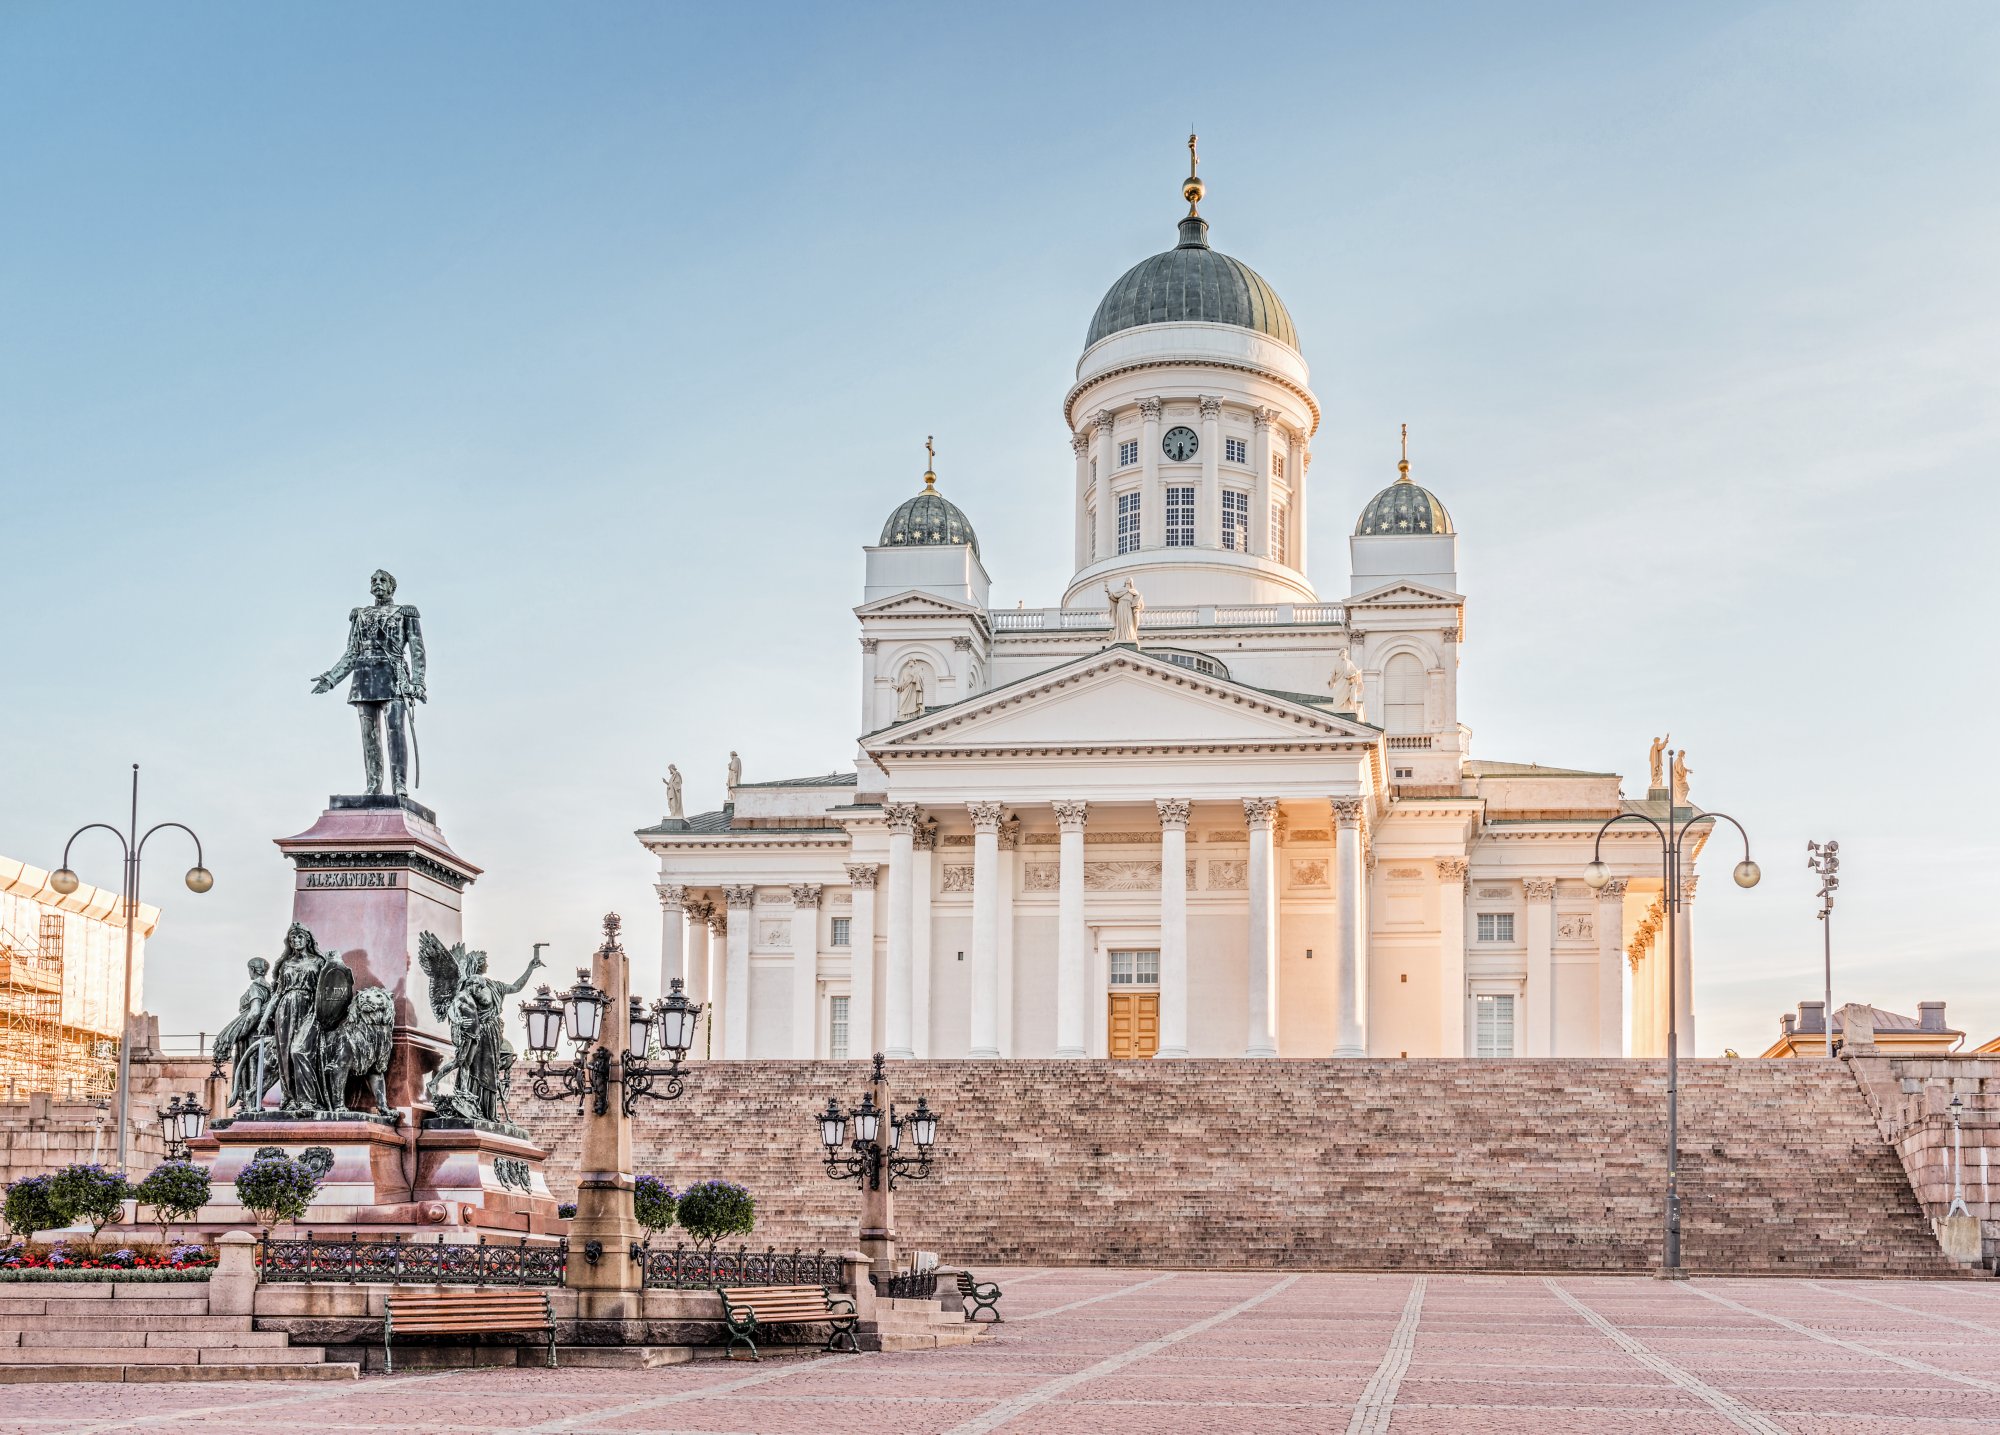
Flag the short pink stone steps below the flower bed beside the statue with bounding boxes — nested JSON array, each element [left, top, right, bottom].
[[0, 1281, 360, 1385]]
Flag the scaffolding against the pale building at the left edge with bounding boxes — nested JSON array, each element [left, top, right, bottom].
[[0, 911, 118, 1101]]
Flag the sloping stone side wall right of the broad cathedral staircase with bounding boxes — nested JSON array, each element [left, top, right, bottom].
[[1846, 1053, 2000, 1265]]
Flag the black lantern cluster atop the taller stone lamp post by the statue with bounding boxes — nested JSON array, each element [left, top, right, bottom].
[[520, 917, 702, 1115]]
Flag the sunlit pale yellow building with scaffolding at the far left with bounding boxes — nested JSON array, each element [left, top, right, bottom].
[[0, 857, 160, 1101]]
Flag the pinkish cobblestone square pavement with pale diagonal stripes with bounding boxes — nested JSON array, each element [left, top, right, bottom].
[[0, 1269, 2000, 1435]]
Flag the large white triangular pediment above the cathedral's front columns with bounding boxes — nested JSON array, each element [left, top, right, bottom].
[[864, 648, 1378, 763]]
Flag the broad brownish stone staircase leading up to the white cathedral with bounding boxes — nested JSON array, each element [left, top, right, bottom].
[[514, 1059, 1958, 1275]]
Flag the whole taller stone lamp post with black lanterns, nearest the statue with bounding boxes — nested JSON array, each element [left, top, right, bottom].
[[520, 913, 702, 1299]]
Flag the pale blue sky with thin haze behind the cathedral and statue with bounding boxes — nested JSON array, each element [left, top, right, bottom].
[[0, 0, 2000, 1055]]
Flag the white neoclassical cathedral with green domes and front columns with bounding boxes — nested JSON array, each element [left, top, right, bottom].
[[638, 154, 1694, 1059]]
